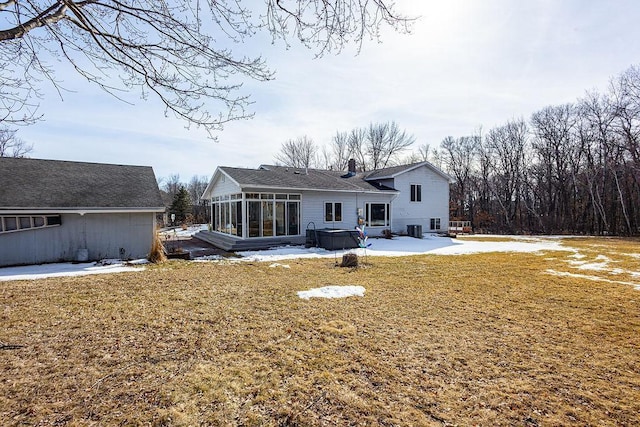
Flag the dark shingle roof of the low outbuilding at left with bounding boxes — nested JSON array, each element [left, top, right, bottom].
[[0, 157, 164, 211]]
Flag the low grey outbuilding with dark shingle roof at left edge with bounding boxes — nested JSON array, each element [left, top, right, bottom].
[[0, 157, 164, 266]]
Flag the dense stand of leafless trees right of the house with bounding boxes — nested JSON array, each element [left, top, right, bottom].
[[433, 66, 640, 235]]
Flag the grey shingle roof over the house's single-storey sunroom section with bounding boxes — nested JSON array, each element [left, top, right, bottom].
[[220, 165, 395, 192]]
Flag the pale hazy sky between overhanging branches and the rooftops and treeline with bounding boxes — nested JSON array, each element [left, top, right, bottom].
[[18, 0, 640, 182]]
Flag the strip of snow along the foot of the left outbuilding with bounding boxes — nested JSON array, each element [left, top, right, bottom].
[[0, 260, 148, 282]]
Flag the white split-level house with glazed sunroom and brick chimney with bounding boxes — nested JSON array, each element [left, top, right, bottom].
[[198, 161, 451, 250]]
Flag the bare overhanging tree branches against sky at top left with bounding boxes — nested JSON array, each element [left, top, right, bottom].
[[0, 0, 410, 130]]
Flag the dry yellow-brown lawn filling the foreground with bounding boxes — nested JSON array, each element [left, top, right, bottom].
[[0, 239, 640, 426]]
